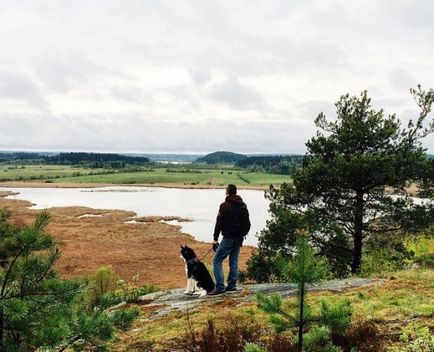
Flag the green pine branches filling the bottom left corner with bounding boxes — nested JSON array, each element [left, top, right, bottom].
[[0, 210, 137, 352]]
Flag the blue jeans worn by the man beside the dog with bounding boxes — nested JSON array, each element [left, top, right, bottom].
[[213, 238, 241, 291]]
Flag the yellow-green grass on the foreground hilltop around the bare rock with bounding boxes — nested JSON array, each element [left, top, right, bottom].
[[111, 269, 434, 352]]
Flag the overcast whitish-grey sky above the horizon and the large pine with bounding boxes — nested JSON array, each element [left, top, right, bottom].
[[0, 0, 434, 153]]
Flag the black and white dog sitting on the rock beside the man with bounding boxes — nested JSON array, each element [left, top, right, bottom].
[[181, 245, 214, 297]]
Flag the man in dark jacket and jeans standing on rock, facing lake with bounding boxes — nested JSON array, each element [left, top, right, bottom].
[[208, 185, 250, 296]]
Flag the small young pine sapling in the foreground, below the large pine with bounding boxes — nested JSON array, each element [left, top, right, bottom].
[[257, 231, 352, 352]]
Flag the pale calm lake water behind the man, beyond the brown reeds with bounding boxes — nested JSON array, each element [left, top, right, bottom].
[[0, 186, 269, 246]]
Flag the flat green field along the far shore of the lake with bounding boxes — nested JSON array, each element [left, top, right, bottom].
[[0, 164, 291, 187]]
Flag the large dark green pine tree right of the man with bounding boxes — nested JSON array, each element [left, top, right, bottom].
[[249, 86, 434, 278]]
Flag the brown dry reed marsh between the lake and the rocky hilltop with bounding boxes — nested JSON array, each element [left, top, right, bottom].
[[0, 192, 252, 289]]
